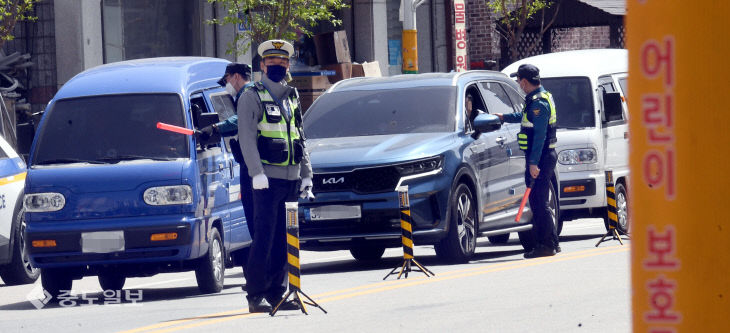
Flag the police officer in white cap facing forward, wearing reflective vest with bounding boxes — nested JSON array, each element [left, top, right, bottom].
[[238, 40, 312, 312]]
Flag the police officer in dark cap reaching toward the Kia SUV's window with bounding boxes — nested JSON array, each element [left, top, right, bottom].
[[497, 64, 560, 258]]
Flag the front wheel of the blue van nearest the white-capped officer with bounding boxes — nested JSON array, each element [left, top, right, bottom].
[[195, 228, 226, 294]]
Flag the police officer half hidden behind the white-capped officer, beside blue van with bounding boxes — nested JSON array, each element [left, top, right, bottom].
[[198, 62, 254, 270]]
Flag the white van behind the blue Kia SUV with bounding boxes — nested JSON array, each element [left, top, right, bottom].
[[502, 49, 629, 233]]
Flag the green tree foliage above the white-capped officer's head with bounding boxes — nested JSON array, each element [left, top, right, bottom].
[[208, 0, 347, 54]]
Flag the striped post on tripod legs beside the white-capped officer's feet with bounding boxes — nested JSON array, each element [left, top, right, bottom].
[[269, 202, 327, 316]]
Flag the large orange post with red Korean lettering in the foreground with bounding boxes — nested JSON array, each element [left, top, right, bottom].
[[626, 0, 730, 332]]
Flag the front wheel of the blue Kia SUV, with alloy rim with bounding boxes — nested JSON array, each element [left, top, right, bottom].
[[435, 183, 478, 263]]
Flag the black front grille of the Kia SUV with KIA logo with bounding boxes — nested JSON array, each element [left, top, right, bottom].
[[313, 166, 400, 194]]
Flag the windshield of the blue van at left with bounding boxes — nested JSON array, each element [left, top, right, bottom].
[[32, 94, 189, 165]]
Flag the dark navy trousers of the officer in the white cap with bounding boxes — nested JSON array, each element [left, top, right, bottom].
[[244, 178, 297, 301]]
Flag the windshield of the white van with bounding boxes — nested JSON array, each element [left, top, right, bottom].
[[541, 77, 596, 129]]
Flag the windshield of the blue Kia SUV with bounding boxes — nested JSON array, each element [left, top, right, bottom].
[[304, 87, 456, 138]]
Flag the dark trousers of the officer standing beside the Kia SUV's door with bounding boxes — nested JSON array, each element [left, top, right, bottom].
[[525, 149, 559, 248]]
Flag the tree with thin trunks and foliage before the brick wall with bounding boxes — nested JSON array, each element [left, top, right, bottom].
[[487, 0, 561, 62]]
